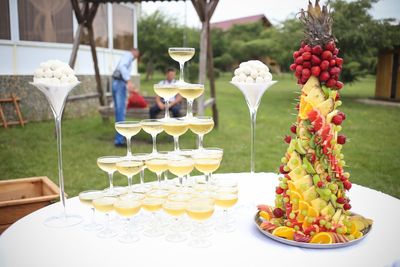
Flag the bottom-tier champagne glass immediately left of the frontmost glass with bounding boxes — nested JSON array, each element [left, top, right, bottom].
[[163, 200, 186, 242]]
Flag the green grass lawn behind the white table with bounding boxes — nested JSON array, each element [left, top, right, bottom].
[[0, 74, 400, 198]]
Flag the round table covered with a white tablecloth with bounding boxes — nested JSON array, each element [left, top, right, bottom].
[[0, 173, 400, 267]]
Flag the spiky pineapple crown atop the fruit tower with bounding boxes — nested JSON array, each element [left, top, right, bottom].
[[299, 0, 337, 46]]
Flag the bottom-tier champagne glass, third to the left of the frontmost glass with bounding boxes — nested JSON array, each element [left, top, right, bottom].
[[114, 198, 142, 243]]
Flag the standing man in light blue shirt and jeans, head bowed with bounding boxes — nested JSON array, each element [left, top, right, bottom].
[[112, 48, 140, 146]]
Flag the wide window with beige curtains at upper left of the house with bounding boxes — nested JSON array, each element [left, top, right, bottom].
[[18, 0, 73, 43]]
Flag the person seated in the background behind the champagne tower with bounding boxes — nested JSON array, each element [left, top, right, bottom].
[[150, 68, 182, 119]]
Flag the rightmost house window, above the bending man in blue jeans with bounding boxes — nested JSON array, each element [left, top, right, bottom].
[[113, 4, 134, 50]]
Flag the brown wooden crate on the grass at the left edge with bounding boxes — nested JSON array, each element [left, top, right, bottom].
[[0, 176, 59, 234]]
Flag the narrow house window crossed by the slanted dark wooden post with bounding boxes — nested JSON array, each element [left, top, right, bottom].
[[81, 4, 108, 47]]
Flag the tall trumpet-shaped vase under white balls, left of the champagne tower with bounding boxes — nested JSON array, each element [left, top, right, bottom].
[[30, 82, 82, 228]]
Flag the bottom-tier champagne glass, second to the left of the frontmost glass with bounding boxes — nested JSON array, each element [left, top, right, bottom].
[[142, 196, 165, 237]]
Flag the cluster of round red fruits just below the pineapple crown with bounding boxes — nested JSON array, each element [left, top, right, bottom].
[[290, 41, 343, 90]]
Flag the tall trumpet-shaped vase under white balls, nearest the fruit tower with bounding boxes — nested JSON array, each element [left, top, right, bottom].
[[231, 81, 276, 174]]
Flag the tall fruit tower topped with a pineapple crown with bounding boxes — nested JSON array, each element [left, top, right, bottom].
[[258, 0, 372, 244]]
